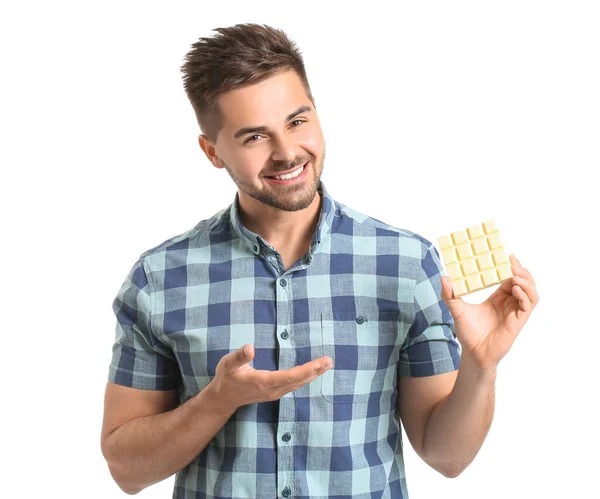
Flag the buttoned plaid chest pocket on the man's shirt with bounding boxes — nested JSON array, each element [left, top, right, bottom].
[[319, 311, 399, 404]]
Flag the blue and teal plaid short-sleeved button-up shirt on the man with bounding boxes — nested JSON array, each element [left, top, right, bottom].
[[108, 182, 461, 499]]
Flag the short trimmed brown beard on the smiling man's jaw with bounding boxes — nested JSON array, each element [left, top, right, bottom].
[[221, 150, 325, 211]]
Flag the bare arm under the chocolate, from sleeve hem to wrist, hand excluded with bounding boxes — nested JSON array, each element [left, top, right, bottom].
[[399, 355, 496, 478]]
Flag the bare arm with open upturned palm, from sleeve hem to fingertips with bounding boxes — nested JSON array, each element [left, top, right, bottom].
[[102, 345, 331, 494]]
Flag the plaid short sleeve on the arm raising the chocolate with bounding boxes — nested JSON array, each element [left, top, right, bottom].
[[399, 244, 461, 376]]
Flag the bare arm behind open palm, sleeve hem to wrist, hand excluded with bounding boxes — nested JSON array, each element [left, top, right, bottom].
[[101, 381, 235, 495]]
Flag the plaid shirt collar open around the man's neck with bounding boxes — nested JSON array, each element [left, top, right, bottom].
[[229, 180, 336, 259]]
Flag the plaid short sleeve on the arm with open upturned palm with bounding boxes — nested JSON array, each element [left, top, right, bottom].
[[108, 259, 180, 390]]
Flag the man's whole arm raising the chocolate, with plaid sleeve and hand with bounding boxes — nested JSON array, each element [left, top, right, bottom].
[[398, 246, 539, 477]]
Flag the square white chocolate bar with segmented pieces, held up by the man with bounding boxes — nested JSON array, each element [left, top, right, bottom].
[[438, 220, 513, 298]]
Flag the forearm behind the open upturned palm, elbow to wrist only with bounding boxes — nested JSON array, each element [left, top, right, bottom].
[[105, 383, 235, 494]]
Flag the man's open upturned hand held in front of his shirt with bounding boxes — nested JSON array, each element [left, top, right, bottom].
[[210, 344, 333, 410]]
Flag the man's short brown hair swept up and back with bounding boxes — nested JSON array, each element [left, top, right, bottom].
[[181, 23, 316, 144]]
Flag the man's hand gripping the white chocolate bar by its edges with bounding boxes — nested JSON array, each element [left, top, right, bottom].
[[441, 255, 540, 369]]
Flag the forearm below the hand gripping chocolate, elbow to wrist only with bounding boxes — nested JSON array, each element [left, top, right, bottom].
[[423, 357, 496, 477]]
